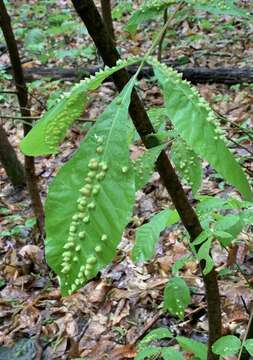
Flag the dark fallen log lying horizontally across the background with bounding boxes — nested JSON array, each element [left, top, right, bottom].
[[4, 61, 253, 85]]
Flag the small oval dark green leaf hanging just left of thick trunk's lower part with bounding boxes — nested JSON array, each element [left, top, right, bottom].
[[164, 277, 191, 320]]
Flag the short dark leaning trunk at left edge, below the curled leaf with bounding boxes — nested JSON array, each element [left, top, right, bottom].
[[0, 124, 26, 189]]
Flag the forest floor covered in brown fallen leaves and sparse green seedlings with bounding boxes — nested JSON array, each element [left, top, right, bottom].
[[0, 1, 253, 360]]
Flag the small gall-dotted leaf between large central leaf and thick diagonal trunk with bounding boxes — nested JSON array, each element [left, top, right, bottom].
[[133, 145, 164, 191]]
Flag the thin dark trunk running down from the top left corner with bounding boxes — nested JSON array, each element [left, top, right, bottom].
[[0, 0, 44, 236]]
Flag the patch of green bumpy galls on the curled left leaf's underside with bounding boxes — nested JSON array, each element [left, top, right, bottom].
[[44, 92, 83, 151]]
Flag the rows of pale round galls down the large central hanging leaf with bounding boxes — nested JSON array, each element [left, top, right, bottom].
[[61, 136, 108, 294]]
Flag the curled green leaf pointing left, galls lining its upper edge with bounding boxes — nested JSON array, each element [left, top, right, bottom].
[[20, 57, 139, 156]]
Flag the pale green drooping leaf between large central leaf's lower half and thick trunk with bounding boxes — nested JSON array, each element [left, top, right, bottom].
[[132, 209, 179, 262]]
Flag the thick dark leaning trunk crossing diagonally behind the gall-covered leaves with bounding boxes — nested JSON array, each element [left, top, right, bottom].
[[72, 0, 221, 360]]
